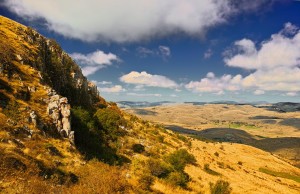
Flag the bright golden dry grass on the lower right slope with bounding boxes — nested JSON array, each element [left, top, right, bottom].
[[186, 140, 300, 193]]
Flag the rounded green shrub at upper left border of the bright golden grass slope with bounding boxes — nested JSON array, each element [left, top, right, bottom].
[[166, 149, 196, 171]]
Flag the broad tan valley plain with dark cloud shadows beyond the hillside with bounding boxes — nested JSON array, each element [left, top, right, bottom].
[[126, 104, 300, 167]]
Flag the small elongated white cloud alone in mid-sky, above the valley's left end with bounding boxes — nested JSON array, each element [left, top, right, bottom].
[[120, 71, 178, 88]]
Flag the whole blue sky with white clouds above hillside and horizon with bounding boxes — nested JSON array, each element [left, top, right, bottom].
[[0, 0, 300, 102]]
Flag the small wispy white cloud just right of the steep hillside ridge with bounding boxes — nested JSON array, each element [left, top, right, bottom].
[[70, 50, 120, 76]]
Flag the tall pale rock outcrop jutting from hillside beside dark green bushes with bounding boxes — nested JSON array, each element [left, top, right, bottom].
[[47, 90, 74, 143]]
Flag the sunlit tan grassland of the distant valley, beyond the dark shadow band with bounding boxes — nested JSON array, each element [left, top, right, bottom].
[[126, 104, 300, 138]]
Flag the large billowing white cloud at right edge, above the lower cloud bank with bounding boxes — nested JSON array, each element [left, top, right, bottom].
[[225, 23, 300, 70]]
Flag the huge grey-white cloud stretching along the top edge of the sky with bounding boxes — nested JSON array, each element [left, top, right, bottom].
[[4, 0, 269, 42]]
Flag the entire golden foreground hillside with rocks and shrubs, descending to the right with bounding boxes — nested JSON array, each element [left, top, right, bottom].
[[0, 16, 300, 194]]
